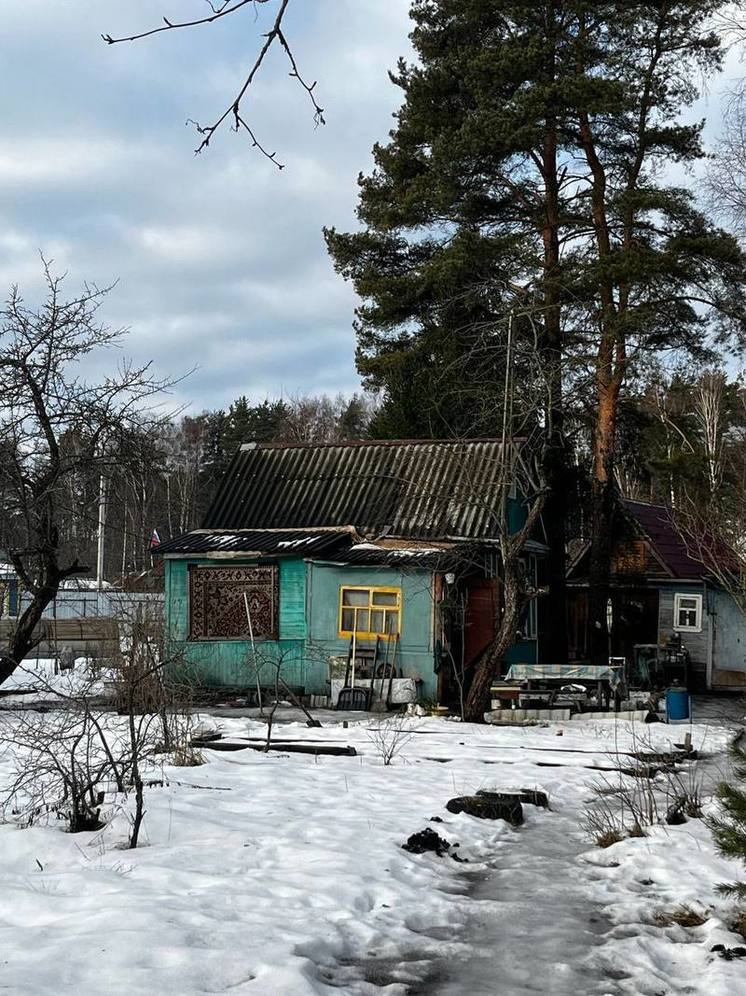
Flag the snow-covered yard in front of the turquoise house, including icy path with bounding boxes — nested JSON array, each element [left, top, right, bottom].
[[0, 713, 746, 996]]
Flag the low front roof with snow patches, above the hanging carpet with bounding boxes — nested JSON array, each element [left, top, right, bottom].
[[153, 529, 355, 557]]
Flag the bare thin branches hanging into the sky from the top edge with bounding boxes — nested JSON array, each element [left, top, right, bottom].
[[101, 0, 326, 169]]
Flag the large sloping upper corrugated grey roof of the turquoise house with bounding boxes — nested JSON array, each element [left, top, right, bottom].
[[203, 439, 502, 539]]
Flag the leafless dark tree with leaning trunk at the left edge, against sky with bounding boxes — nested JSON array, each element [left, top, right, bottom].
[[0, 263, 174, 682]]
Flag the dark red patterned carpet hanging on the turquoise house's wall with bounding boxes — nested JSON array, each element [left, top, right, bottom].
[[189, 565, 278, 640]]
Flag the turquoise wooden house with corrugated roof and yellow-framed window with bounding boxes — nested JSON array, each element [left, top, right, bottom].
[[155, 440, 546, 700]]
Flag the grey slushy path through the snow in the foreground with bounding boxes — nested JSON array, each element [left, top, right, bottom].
[[415, 812, 615, 996]]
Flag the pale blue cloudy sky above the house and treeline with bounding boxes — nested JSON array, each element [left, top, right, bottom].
[[0, 0, 742, 411]]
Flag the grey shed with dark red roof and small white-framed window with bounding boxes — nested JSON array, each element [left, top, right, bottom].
[[568, 500, 746, 689]]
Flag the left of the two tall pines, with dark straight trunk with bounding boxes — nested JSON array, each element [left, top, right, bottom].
[[326, 0, 587, 661]]
